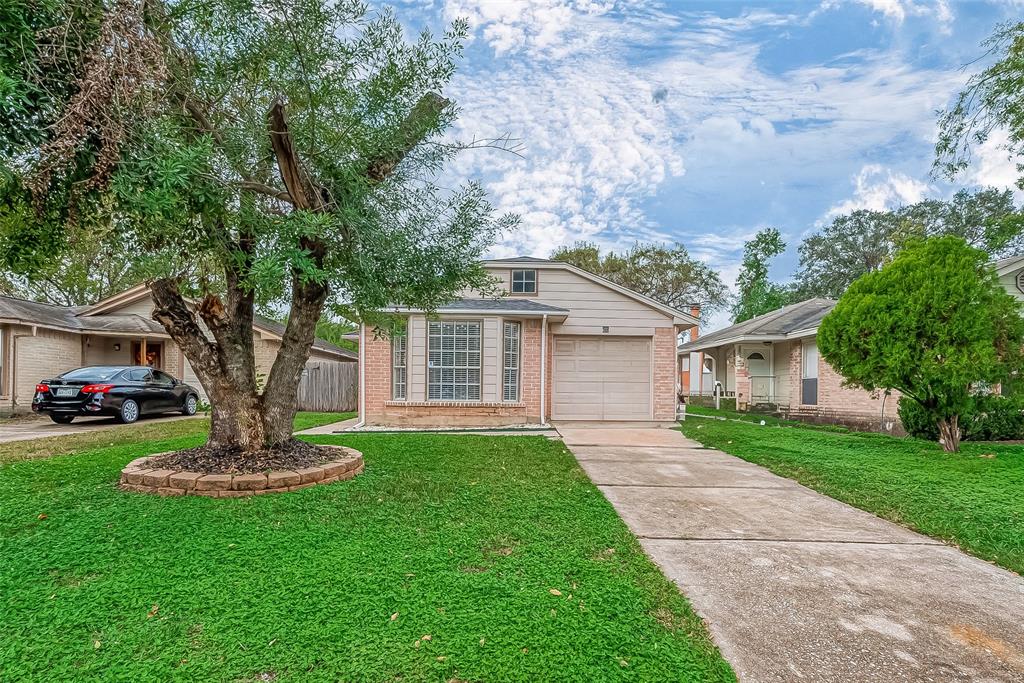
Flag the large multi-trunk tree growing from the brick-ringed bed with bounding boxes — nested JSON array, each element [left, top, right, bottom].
[[0, 0, 510, 453]]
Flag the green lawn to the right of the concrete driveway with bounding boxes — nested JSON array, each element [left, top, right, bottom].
[[682, 418, 1024, 573]]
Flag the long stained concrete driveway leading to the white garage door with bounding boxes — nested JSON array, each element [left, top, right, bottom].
[[559, 427, 1024, 682]]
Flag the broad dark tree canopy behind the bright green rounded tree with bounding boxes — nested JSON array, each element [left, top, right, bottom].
[[794, 187, 1024, 300]]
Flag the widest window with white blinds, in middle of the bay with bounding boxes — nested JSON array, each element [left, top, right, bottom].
[[427, 321, 480, 400]]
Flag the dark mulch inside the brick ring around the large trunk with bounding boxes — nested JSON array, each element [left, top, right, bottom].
[[150, 439, 338, 474]]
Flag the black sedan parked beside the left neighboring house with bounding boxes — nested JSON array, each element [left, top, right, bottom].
[[32, 366, 199, 424]]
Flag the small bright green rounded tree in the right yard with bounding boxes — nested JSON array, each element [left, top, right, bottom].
[[818, 237, 1024, 452]]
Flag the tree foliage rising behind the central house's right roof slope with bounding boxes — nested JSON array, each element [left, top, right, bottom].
[[551, 242, 726, 315]]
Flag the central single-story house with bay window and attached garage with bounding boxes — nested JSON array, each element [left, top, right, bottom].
[[359, 257, 697, 426]]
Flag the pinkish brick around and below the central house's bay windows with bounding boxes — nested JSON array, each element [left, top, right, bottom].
[[364, 319, 551, 426]]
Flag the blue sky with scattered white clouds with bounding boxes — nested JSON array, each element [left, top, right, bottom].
[[389, 0, 1024, 328]]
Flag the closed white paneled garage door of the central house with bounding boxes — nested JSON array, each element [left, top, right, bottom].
[[551, 337, 651, 420]]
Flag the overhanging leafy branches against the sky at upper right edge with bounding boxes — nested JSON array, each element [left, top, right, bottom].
[[934, 23, 1024, 187]]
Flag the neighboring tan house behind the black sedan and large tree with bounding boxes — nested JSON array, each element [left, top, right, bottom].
[[0, 285, 357, 414]]
